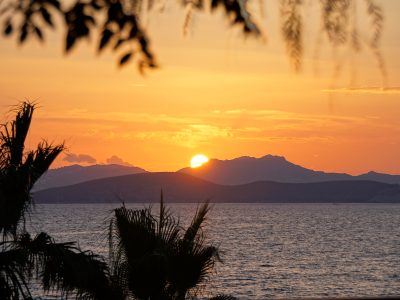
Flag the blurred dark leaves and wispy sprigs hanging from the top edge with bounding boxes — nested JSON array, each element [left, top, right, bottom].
[[0, 0, 385, 74]]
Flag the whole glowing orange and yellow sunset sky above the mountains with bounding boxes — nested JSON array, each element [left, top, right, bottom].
[[0, 0, 400, 174]]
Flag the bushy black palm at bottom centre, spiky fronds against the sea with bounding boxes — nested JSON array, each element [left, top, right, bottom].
[[109, 194, 220, 300]]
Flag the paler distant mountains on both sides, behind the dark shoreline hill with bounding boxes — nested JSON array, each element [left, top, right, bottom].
[[34, 155, 400, 191]]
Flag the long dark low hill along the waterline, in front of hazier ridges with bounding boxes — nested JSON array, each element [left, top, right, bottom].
[[33, 173, 400, 203]]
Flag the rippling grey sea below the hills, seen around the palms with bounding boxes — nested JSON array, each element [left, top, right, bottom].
[[28, 203, 400, 299]]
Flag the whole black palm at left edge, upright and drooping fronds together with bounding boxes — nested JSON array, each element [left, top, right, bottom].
[[0, 102, 121, 299]]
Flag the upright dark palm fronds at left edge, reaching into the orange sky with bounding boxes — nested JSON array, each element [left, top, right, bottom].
[[0, 102, 64, 237]]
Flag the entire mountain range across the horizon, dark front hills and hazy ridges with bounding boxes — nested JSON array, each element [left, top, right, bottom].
[[33, 155, 400, 203]]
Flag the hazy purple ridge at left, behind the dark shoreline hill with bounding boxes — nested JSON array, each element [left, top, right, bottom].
[[33, 164, 147, 191]]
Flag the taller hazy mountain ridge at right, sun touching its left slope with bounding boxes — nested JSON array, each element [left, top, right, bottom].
[[178, 155, 400, 185]]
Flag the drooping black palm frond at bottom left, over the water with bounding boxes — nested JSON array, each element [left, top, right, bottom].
[[15, 232, 122, 299]]
